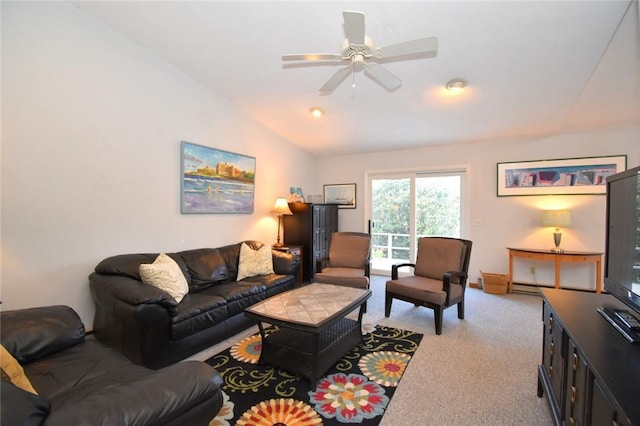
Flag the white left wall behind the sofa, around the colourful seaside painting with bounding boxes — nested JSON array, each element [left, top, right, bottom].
[[1, 2, 315, 328]]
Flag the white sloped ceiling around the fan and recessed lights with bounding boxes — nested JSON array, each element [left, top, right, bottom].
[[75, 0, 640, 156]]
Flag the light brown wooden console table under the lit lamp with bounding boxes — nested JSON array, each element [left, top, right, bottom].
[[507, 247, 602, 293]]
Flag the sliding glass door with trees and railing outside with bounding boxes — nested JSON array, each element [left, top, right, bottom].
[[368, 169, 466, 275]]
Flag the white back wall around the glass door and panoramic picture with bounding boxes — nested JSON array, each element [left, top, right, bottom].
[[316, 127, 640, 289]]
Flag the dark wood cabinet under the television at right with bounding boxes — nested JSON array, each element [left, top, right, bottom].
[[538, 289, 640, 425]]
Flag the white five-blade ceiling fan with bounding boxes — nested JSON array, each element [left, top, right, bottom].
[[282, 10, 438, 95]]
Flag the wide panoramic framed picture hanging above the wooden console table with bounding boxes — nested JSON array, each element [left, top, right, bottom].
[[498, 155, 627, 197]]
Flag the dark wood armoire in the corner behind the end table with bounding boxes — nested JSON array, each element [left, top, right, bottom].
[[283, 203, 338, 282]]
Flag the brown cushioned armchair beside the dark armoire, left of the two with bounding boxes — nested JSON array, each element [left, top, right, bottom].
[[314, 232, 371, 288]]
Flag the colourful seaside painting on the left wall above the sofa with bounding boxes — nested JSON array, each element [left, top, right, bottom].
[[180, 141, 256, 214]]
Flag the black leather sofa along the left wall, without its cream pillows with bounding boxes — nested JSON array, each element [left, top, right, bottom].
[[89, 241, 300, 368]]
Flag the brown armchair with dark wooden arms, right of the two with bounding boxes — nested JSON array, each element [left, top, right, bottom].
[[384, 237, 472, 334]]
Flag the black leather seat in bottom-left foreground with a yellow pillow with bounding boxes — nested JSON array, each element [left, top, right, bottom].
[[0, 306, 222, 426]]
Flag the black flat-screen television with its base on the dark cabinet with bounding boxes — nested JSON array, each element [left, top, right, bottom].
[[598, 167, 640, 343]]
